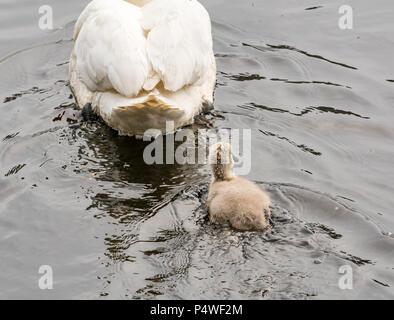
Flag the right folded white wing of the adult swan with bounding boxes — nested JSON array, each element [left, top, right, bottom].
[[142, 0, 212, 91]]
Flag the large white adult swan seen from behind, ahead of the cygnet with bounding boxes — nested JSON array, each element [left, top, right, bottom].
[[70, 0, 216, 136]]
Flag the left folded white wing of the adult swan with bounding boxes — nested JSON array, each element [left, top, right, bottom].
[[74, 0, 150, 97]]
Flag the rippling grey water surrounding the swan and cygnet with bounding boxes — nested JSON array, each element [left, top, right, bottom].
[[0, 0, 394, 299]]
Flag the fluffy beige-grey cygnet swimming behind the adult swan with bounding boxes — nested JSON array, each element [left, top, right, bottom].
[[206, 142, 271, 230]]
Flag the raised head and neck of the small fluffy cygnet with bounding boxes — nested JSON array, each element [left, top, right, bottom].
[[208, 142, 234, 181]]
